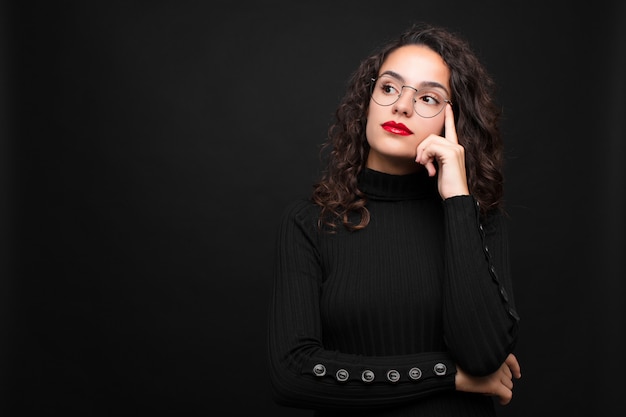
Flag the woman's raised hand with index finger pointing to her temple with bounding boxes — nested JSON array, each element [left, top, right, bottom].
[[415, 104, 469, 199]]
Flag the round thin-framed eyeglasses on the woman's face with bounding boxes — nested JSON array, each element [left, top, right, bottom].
[[370, 75, 452, 119]]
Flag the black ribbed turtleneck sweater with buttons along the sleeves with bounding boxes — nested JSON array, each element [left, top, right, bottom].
[[268, 169, 518, 417]]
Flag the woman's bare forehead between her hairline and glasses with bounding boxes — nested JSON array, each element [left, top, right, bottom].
[[379, 45, 450, 89]]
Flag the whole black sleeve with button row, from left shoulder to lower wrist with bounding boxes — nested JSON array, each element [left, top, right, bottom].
[[268, 201, 456, 410]]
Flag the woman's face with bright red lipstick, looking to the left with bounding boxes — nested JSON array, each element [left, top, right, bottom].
[[365, 45, 451, 174]]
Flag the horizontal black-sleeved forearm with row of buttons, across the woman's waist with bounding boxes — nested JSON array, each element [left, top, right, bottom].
[[269, 308, 456, 409]]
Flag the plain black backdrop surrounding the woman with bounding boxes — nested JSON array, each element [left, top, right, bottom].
[[0, 0, 626, 416]]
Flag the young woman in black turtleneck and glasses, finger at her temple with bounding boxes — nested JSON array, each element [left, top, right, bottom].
[[268, 25, 521, 417]]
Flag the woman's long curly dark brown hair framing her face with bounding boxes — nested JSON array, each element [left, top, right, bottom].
[[312, 23, 503, 230]]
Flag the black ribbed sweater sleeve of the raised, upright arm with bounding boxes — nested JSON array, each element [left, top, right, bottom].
[[443, 196, 519, 375]]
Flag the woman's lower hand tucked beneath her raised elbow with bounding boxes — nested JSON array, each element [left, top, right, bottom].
[[454, 353, 522, 405]]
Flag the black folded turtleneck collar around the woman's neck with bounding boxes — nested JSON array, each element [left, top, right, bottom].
[[358, 168, 439, 201]]
